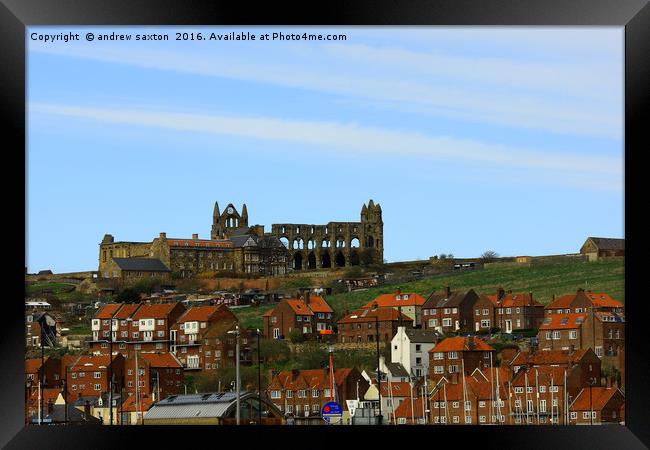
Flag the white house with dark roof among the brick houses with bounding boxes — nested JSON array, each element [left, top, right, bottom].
[[391, 327, 441, 377]]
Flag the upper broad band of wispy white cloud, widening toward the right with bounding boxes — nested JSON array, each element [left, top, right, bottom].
[[30, 33, 623, 139]]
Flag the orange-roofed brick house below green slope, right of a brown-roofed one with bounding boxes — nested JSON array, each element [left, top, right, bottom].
[[474, 288, 544, 333]]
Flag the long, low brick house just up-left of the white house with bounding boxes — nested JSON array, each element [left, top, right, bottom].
[[337, 307, 413, 343]]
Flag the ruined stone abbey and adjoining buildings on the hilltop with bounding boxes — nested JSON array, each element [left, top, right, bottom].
[[99, 200, 384, 281]]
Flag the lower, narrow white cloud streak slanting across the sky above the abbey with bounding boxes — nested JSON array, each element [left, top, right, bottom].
[[29, 103, 622, 191]]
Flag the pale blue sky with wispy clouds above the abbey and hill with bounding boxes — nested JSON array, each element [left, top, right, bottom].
[[26, 27, 624, 272]]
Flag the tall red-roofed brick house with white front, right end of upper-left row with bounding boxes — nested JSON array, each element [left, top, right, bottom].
[[171, 305, 250, 371]]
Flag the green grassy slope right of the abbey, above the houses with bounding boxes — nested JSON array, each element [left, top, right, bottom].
[[237, 260, 625, 329]]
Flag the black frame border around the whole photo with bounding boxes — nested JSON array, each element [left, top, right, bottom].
[[0, 0, 650, 450]]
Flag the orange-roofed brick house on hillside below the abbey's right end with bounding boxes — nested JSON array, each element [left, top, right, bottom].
[[263, 295, 334, 339]]
